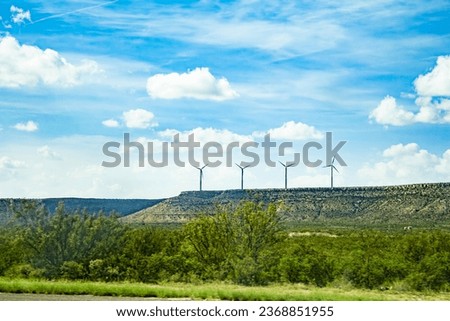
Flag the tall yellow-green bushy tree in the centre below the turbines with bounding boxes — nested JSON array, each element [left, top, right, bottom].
[[184, 201, 282, 284]]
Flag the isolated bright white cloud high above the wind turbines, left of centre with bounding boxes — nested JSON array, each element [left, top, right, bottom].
[[147, 68, 239, 101]]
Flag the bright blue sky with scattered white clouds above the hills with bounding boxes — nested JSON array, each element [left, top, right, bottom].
[[0, 0, 450, 198]]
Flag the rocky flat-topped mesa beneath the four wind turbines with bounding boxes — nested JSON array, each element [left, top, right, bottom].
[[123, 183, 450, 225]]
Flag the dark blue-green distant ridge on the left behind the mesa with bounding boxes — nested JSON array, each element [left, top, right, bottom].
[[0, 198, 162, 216]]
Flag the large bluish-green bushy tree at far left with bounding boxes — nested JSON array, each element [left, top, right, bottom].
[[11, 201, 124, 277]]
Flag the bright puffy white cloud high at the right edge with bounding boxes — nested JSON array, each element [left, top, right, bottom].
[[369, 56, 450, 126]]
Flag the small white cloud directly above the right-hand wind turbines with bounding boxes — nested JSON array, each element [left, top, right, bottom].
[[253, 120, 324, 140]]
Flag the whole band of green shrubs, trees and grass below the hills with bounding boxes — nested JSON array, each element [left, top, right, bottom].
[[0, 201, 450, 300]]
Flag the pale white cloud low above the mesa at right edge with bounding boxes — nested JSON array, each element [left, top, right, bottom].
[[358, 143, 450, 184]]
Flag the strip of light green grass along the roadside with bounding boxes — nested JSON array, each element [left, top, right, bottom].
[[0, 278, 450, 301]]
